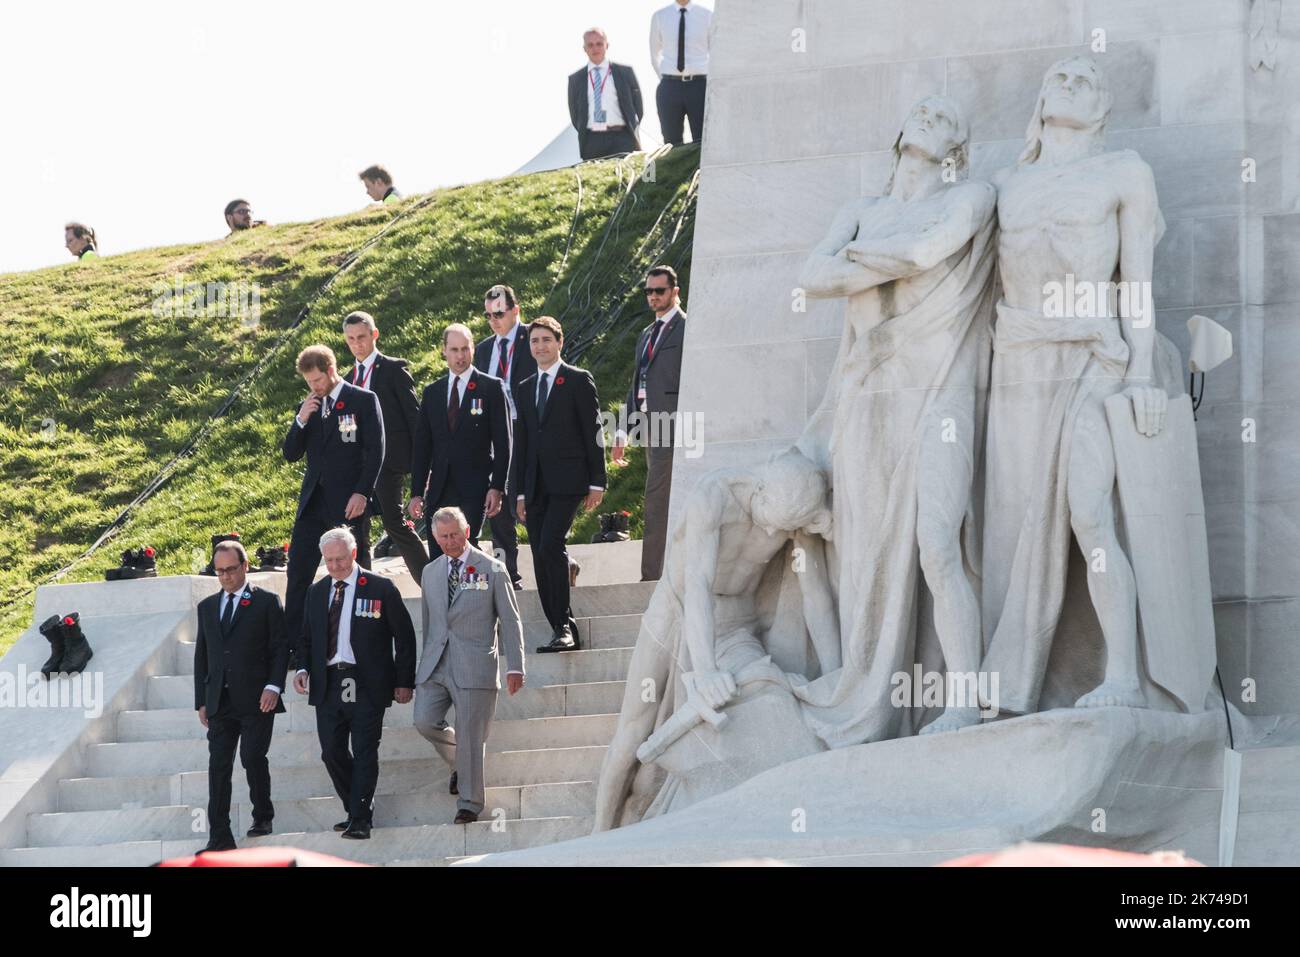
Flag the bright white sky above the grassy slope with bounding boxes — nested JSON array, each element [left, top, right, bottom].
[[0, 0, 696, 272]]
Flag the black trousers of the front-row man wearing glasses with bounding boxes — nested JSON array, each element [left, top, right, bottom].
[[208, 689, 276, 836]]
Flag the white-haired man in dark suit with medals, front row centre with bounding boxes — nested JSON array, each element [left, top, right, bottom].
[[294, 528, 415, 840]]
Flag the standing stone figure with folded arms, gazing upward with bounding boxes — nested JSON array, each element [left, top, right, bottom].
[[796, 96, 996, 748]]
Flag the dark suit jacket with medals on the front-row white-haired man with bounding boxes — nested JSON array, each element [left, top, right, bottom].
[[296, 568, 415, 709]]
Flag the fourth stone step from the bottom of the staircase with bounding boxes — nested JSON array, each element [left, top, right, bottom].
[[85, 714, 618, 778]]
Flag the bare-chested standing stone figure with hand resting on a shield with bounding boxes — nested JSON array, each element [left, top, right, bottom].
[[983, 57, 1177, 713]]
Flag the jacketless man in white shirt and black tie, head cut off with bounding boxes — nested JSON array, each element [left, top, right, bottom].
[[650, 0, 714, 146]]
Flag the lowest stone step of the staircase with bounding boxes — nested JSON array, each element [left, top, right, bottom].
[[0, 817, 592, 867]]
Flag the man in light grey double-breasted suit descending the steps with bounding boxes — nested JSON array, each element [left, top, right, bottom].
[[415, 507, 524, 824]]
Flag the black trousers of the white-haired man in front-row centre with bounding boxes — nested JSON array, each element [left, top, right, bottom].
[[316, 668, 384, 824]]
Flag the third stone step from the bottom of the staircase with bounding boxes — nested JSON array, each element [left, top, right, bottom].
[[59, 745, 605, 811]]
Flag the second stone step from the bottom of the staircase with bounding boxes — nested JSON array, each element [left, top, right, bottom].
[[27, 781, 595, 846]]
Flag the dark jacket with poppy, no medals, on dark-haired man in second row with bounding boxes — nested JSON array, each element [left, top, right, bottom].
[[510, 360, 605, 503]]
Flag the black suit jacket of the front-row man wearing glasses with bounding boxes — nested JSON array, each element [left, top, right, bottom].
[[194, 584, 289, 718]]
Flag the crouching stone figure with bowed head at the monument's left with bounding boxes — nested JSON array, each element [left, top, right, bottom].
[[595, 451, 839, 831]]
